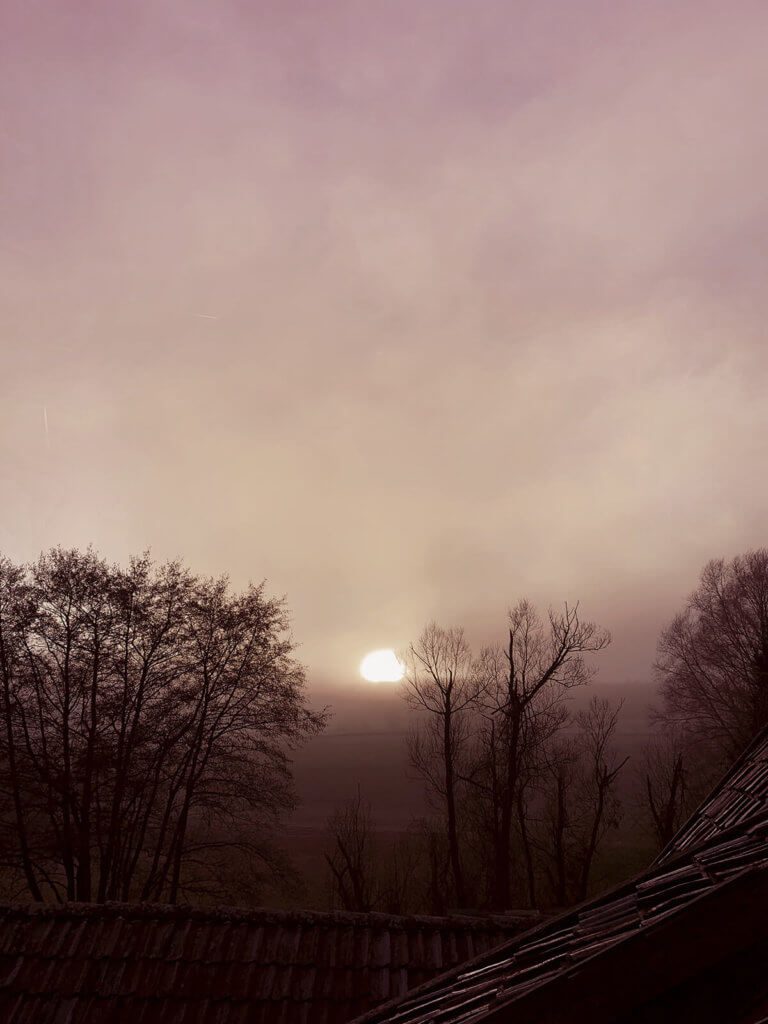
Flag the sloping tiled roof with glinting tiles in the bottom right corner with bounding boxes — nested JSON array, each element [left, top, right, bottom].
[[360, 811, 768, 1024]]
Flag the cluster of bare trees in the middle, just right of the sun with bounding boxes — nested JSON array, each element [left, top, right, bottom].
[[329, 601, 624, 913]]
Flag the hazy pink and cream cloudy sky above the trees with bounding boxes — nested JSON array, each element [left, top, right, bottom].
[[0, 0, 768, 686]]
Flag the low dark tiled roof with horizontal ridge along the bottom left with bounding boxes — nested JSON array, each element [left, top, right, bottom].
[[0, 904, 524, 1024]]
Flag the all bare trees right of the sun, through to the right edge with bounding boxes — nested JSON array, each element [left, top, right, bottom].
[[327, 550, 768, 913]]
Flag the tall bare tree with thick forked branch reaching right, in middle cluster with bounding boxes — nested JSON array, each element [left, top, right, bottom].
[[473, 600, 610, 908]]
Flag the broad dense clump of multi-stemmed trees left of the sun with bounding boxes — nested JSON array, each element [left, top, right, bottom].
[[0, 549, 323, 902]]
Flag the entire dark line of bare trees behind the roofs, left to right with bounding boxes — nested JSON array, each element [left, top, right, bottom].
[[0, 549, 768, 913]]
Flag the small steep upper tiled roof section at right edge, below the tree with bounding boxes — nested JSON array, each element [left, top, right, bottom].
[[654, 729, 768, 864]]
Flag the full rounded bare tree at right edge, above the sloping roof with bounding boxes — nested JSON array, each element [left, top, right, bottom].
[[656, 548, 768, 760]]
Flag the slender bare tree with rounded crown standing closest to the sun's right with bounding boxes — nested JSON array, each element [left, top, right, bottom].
[[403, 623, 480, 906]]
